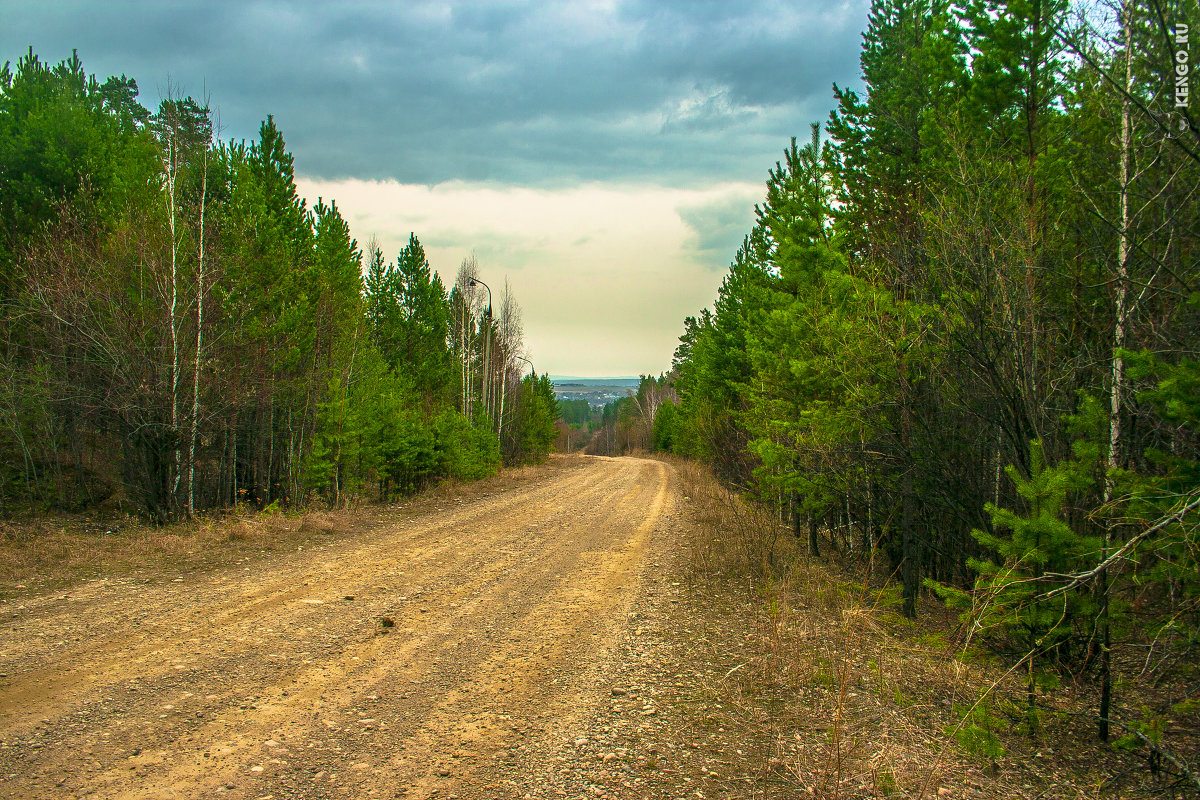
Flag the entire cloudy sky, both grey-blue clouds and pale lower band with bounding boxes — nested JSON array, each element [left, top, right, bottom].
[[0, 0, 868, 375]]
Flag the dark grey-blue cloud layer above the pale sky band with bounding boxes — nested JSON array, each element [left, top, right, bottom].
[[0, 0, 865, 185]]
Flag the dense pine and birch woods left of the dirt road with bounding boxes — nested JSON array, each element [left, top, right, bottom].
[[0, 50, 556, 521]]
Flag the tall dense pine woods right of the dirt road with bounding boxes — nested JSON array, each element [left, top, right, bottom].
[[662, 0, 1200, 762]]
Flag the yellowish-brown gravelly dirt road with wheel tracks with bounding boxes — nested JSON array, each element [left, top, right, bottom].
[[0, 458, 679, 799]]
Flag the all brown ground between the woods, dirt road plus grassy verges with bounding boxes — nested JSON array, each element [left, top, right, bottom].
[[0, 457, 1185, 800]]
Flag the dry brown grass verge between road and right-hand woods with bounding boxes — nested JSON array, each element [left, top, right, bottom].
[[677, 464, 1194, 798]]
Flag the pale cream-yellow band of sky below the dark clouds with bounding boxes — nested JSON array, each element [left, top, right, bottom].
[[296, 176, 762, 378]]
